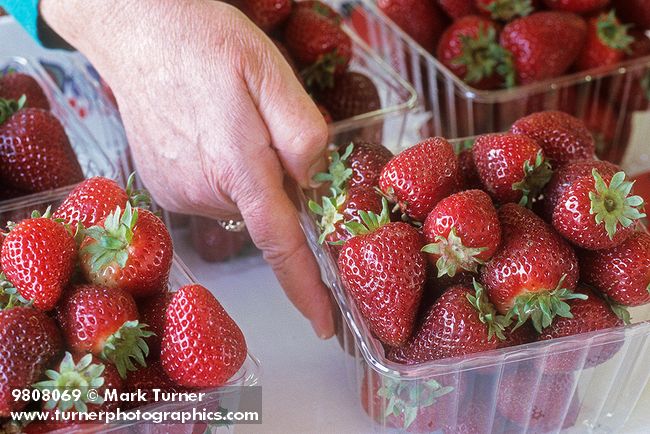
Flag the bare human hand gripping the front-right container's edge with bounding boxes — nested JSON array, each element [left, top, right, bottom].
[[40, 0, 334, 338]]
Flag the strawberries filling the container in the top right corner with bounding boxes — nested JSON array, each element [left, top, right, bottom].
[[377, 0, 650, 89]]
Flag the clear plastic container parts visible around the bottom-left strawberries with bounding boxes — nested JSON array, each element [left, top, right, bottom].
[[0, 188, 262, 434]]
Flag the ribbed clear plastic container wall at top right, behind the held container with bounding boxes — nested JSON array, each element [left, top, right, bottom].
[[329, 0, 650, 162]]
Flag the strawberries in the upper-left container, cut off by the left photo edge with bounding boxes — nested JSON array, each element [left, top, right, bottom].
[[0, 72, 84, 200]]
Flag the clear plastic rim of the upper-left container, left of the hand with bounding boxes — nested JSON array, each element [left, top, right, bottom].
[[0, 57, 118, 206]]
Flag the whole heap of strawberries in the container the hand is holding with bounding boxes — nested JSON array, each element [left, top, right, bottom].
[[310, 107, 650, 364]]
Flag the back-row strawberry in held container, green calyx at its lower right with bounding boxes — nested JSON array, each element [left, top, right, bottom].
[[473, 133, 552, 205]]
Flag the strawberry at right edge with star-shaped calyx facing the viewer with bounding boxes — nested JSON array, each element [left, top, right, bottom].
[[553, 169, 645, 250]]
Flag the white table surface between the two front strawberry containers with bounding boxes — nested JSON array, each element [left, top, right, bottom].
[[0, 17, 650, 434]]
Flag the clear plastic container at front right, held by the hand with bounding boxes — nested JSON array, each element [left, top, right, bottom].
[[294, 134, 650, 434]]
